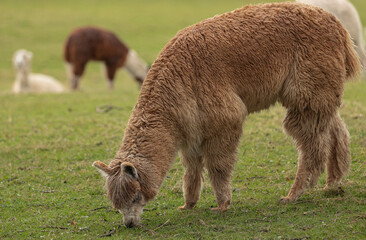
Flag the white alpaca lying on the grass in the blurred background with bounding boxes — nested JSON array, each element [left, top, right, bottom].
[[13, 49, 65, 93]]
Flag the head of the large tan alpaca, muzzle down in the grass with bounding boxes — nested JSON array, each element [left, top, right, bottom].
[[93, 161, 147, 227]]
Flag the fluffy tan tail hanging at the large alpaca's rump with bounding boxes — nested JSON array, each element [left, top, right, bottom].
[[345, 33, 362, 80]]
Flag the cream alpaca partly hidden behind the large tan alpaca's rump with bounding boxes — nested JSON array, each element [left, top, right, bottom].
[[296, 0, 366, 69]]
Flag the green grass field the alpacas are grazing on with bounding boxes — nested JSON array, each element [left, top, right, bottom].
[[0, 0, 366, 239]]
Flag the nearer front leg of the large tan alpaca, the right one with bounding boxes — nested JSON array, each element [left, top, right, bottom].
[[202, 91, 248, 212]]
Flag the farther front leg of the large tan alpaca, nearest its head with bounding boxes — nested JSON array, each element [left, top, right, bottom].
[[179, 151, 203, 210]]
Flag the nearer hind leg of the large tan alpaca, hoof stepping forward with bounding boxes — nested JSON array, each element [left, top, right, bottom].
[[281, 109, 332, 203]]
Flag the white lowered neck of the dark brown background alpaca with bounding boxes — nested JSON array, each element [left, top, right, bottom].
[[125, 49, 148, 83]]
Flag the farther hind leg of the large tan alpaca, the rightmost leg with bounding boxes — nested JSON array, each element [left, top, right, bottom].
[[327, 114, 351, 188]]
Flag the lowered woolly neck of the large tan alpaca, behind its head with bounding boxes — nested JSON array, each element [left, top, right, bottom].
[[117, 108, 178, 199]]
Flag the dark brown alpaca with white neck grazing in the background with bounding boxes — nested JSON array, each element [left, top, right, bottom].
[[64, 27, 149, 90]]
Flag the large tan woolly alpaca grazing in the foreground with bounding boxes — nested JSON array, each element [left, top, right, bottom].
[[93, 3, 360, 227]]
